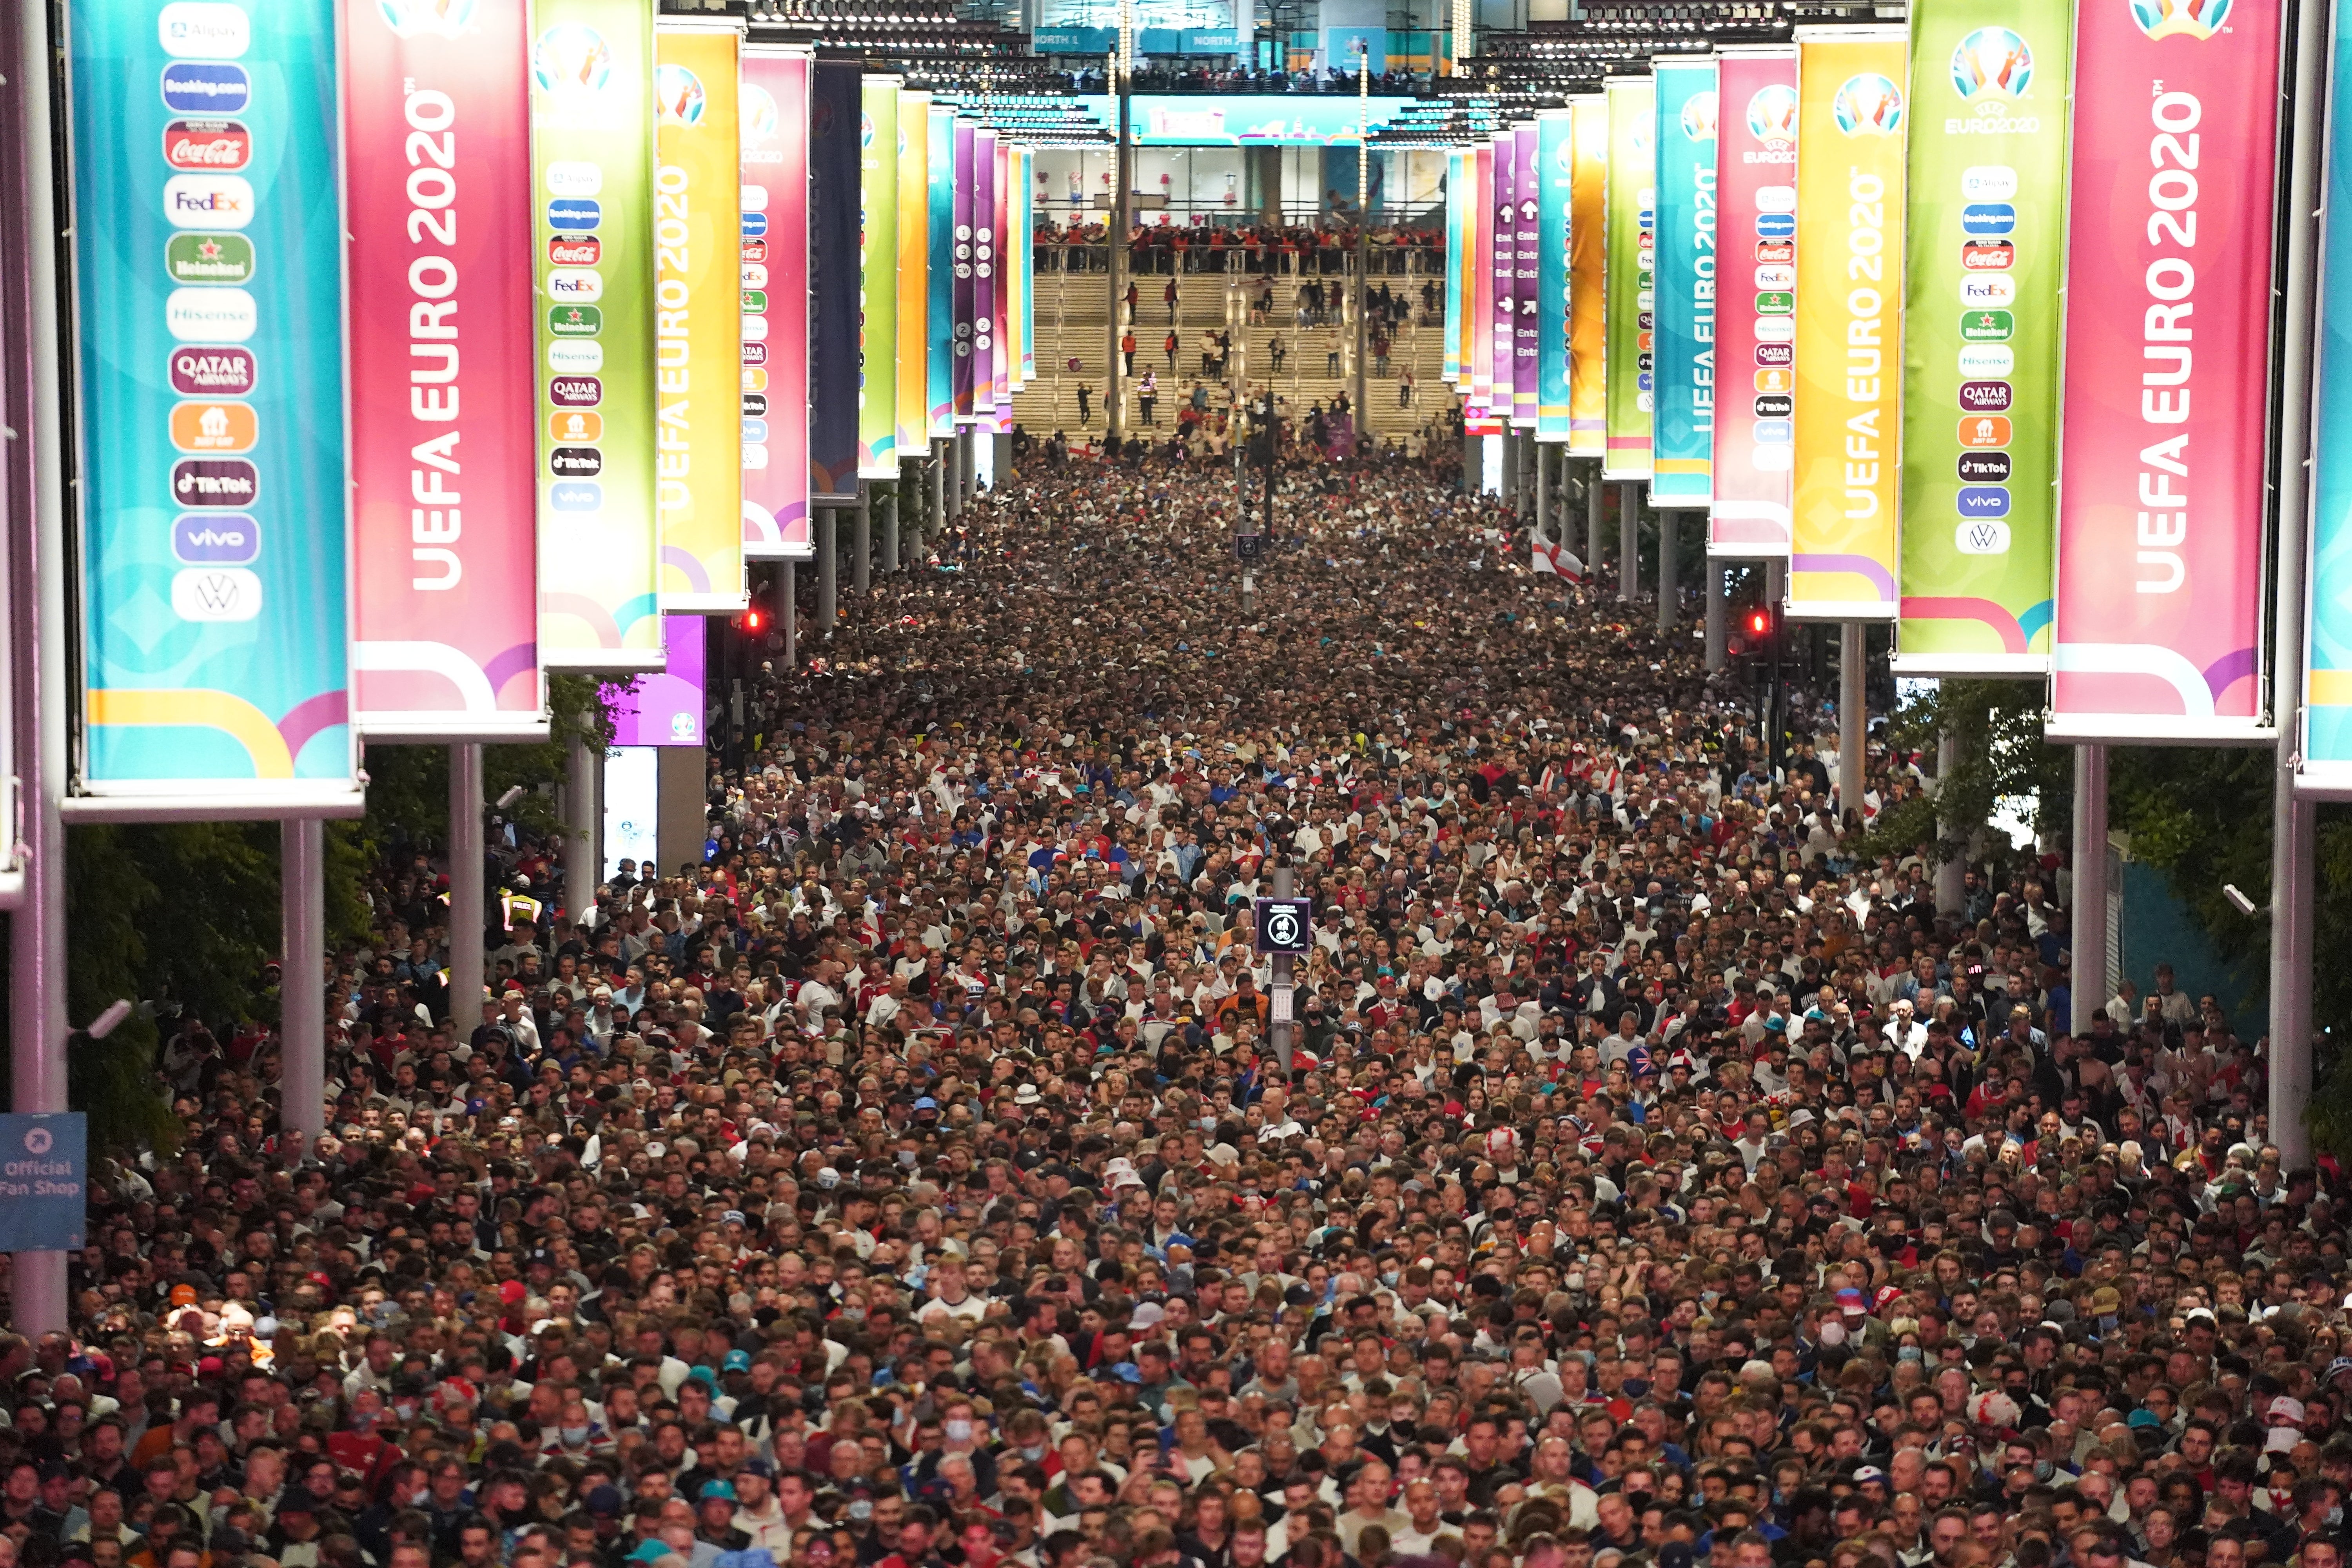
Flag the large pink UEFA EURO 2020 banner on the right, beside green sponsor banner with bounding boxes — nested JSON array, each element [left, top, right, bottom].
[[2060, 0, 2279, 740]]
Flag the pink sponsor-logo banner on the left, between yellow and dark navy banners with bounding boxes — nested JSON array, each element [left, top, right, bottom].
[[743, 45, 816, 562]]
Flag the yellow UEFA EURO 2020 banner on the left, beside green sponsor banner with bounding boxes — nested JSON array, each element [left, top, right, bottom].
[[654, 19, 748, 616]]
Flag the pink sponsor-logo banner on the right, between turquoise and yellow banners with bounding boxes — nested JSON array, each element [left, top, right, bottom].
[[1708, 45, 1797, 559]]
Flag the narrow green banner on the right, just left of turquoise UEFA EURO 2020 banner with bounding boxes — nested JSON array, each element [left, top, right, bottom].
[[1602, 75, 1658, 479]]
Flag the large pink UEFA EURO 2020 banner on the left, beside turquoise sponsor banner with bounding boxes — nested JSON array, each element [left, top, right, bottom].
[[343, 0, 539, 740]]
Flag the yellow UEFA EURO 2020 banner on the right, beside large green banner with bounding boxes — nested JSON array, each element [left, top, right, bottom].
[[1788, 28, 1900, 621]]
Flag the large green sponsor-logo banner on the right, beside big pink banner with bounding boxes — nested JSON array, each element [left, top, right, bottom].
[[1896, 0, 2072, 677]]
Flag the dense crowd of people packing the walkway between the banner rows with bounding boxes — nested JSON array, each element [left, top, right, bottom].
[[0, 451, 2314, 1568]]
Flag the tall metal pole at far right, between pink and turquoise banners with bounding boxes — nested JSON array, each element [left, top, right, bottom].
[[2270, 0, 2336, 1171]]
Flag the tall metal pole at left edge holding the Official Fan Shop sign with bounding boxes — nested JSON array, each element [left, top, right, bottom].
[[0, 5, 71, 1340]]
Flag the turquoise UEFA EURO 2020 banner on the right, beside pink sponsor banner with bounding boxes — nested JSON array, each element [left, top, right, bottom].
[[1649, 59, 1715, 508]]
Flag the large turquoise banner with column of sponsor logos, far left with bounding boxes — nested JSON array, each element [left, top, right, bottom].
[[68, 0, 353, 809]]
